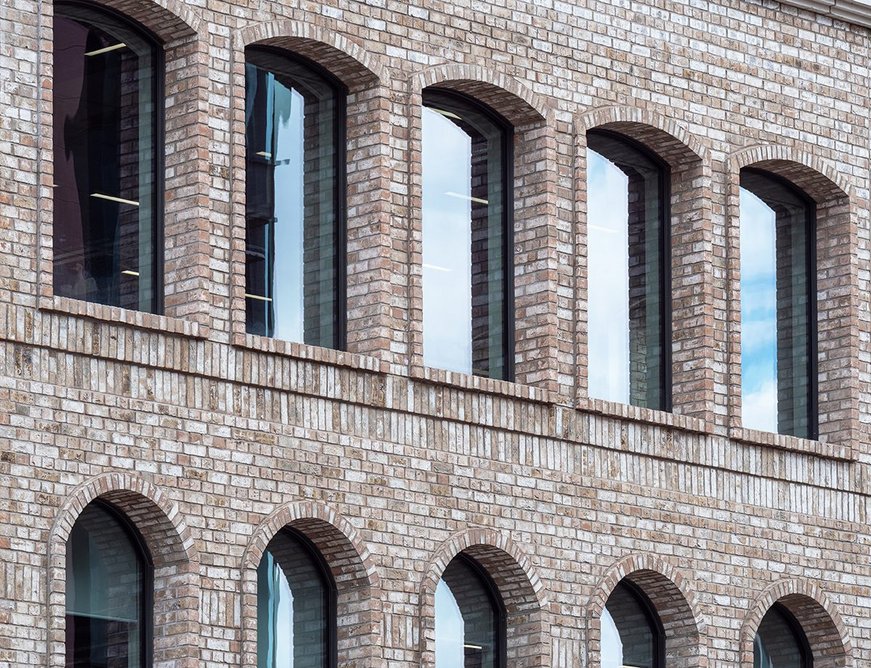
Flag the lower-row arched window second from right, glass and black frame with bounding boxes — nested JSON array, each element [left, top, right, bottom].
[[600, 580, 665, 668]]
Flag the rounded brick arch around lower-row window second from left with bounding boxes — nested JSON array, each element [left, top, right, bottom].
[[242, 501, 383, 666]]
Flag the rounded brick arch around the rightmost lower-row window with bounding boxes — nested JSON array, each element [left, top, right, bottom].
[[740, 579, 855, 668]]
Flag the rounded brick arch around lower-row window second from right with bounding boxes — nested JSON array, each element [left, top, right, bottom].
[[587, 554, 708, 668]]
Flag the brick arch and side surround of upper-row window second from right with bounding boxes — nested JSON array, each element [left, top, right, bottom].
[[575, 106, 725, 422]]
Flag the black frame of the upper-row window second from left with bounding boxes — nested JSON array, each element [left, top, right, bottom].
[[245, 44, 349, 350]]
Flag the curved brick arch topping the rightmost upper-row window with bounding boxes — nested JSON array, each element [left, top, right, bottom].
[[729, 144, 855, 204]]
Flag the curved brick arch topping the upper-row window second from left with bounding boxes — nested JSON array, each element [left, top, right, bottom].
[[233, 15, 390, 92]]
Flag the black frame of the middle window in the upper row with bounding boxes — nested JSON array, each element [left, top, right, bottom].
[[421, 84, 515, 382]]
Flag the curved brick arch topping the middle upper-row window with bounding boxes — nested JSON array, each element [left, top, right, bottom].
[[408, 63, 554, 127]]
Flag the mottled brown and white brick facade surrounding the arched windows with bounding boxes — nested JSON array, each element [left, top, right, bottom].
[[0, 0, 871, 668]]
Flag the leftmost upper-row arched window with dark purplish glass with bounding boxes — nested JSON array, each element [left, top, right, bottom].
[[53, 4, 163, 313]]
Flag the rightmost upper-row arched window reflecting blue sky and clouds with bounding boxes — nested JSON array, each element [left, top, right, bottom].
[[740, 169, 817, 438]]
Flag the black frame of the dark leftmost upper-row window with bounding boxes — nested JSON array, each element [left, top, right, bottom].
[[52, 0, 166, 315]]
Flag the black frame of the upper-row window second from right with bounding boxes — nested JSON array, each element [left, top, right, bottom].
[[587, 127, 674, 413]]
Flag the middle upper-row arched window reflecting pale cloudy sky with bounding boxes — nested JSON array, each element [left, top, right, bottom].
[[422, 89, 514, 380]]
